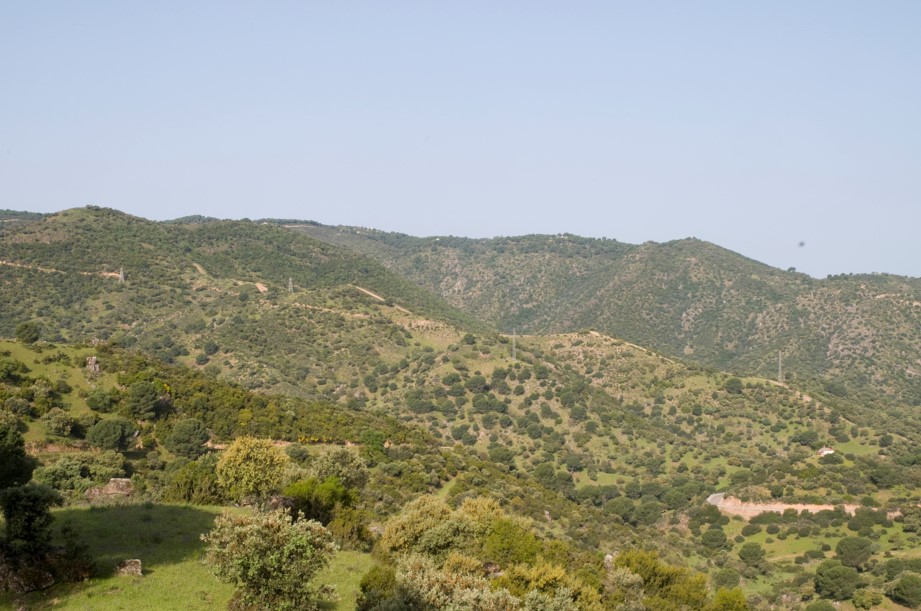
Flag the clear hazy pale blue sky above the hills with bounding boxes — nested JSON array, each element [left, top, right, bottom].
[[0, 0, 921, 276]]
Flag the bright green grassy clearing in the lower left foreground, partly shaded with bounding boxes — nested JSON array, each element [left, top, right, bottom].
[[0, 504, 373, 611]]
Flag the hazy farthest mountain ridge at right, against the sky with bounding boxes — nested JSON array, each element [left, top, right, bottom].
[[295, 223, 921, 404]]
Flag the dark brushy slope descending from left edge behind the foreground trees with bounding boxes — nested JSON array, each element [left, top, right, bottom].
[[0, 342, 634, 545]]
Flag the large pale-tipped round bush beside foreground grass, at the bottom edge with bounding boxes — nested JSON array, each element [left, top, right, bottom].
[[202, 511, 336, 611]]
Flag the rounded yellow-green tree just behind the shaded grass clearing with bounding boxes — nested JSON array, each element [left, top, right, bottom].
[[217, 437, 288, 503]]
